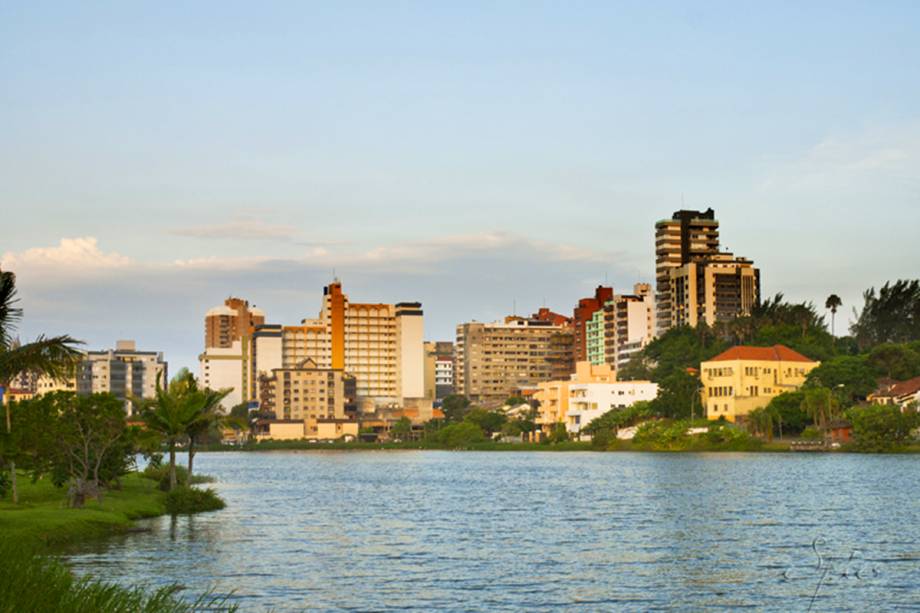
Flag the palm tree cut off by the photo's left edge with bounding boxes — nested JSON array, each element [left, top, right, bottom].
[[0, 271, 82, 503]]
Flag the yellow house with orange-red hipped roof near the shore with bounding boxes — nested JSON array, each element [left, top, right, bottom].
[[700, 345, 821, 422]]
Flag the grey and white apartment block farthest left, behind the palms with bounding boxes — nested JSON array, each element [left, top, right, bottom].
[[76, 341, 168, 415]]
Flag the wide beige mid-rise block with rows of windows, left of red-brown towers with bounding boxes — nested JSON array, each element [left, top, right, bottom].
[[454, 316, 574, 406]]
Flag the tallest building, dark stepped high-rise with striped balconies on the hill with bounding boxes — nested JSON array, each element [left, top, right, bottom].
[[655, 208, 760, 334]]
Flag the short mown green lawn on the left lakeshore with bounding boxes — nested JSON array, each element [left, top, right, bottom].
[[0, 474, 166, 547]]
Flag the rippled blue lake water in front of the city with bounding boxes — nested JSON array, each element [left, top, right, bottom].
[[69, 451, 920, 611]]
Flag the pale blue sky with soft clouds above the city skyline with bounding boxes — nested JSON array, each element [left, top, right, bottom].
[[0, 0, 920, 372]]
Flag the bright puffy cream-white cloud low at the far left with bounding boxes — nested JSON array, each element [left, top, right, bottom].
[[0, 236, 134, 274]]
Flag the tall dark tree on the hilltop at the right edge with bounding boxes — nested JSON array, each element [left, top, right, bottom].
[[850, 279, 920, 350]]
